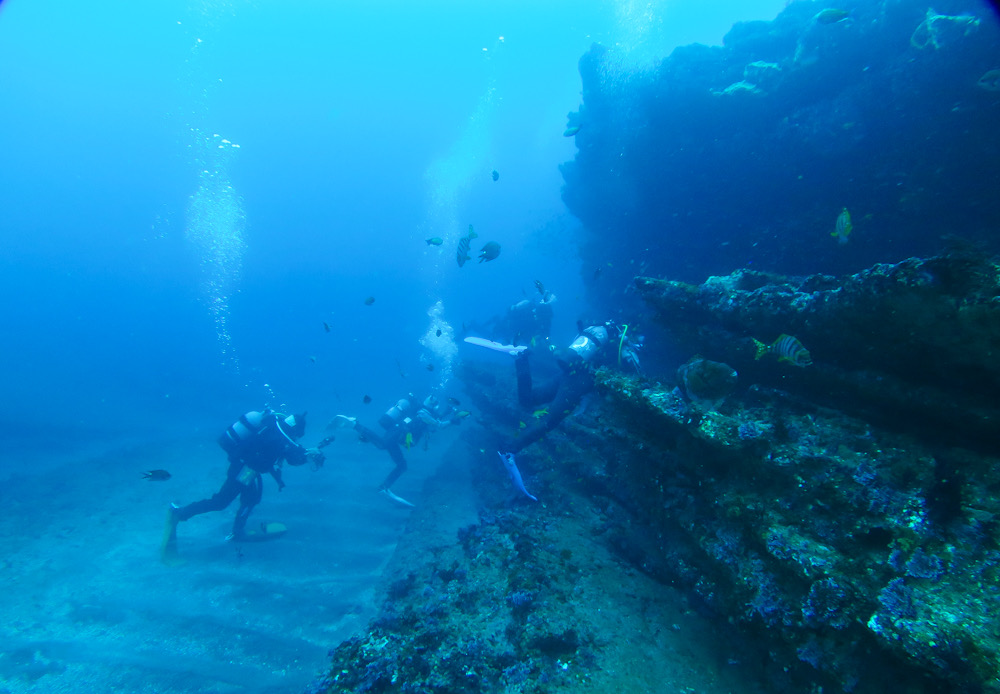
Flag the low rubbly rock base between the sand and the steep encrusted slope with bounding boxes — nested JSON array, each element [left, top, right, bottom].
[[316, 420, 764, 694]]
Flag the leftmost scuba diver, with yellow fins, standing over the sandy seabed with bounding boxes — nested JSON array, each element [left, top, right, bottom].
[[163, 408, 325, 556]]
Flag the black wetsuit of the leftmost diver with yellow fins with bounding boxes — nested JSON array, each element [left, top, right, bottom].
[[174, 413, 307, 537]]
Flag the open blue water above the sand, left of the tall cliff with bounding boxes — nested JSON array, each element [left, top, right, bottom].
[[0, 0, 784, 446]]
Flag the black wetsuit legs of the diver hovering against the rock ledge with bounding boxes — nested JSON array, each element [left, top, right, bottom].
[[502, 351, 594, 453]]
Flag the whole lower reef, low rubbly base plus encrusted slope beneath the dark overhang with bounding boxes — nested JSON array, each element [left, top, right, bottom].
[[314, 348, 1000, 694]]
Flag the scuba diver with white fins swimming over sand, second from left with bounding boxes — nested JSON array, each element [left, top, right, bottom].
[[330, 394, 461, 507]]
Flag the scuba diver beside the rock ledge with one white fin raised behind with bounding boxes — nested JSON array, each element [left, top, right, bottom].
[[482, 321, 642, 453]]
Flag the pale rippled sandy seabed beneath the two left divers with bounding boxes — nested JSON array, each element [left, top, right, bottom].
[[0, 435, 443, 694]]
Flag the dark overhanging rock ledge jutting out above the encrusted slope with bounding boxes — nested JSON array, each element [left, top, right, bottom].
[[635, 251, 1000, 452]]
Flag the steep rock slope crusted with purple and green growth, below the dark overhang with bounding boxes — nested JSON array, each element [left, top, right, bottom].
[[589, 372, 1000, 692]]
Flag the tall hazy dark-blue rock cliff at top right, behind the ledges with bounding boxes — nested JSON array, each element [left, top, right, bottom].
[[562, 0, 1000, 302]]
